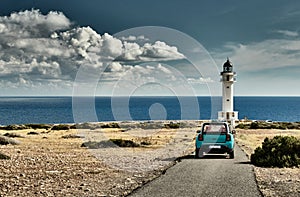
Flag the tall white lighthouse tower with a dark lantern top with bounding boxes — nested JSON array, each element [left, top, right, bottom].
[[218, 58, 238, 122]]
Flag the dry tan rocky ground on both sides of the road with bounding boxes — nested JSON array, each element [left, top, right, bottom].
[[0, 122, 300, 196]]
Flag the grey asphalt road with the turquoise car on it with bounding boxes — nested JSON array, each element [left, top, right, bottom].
[[130, 146, 261, 197]]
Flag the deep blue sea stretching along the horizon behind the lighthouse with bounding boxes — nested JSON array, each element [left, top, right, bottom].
[[0, 96, 300, 125]]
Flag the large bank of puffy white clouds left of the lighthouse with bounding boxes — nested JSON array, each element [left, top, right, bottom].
[[0, 10, 184, 94]]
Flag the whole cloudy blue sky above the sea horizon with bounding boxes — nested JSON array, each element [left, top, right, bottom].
[[0, 0, 300, 96]]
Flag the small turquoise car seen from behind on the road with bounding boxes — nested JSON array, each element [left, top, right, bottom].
[[195, 122, 234, 159]]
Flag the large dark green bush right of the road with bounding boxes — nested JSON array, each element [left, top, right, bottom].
[[251, 136, 300, 168]]
